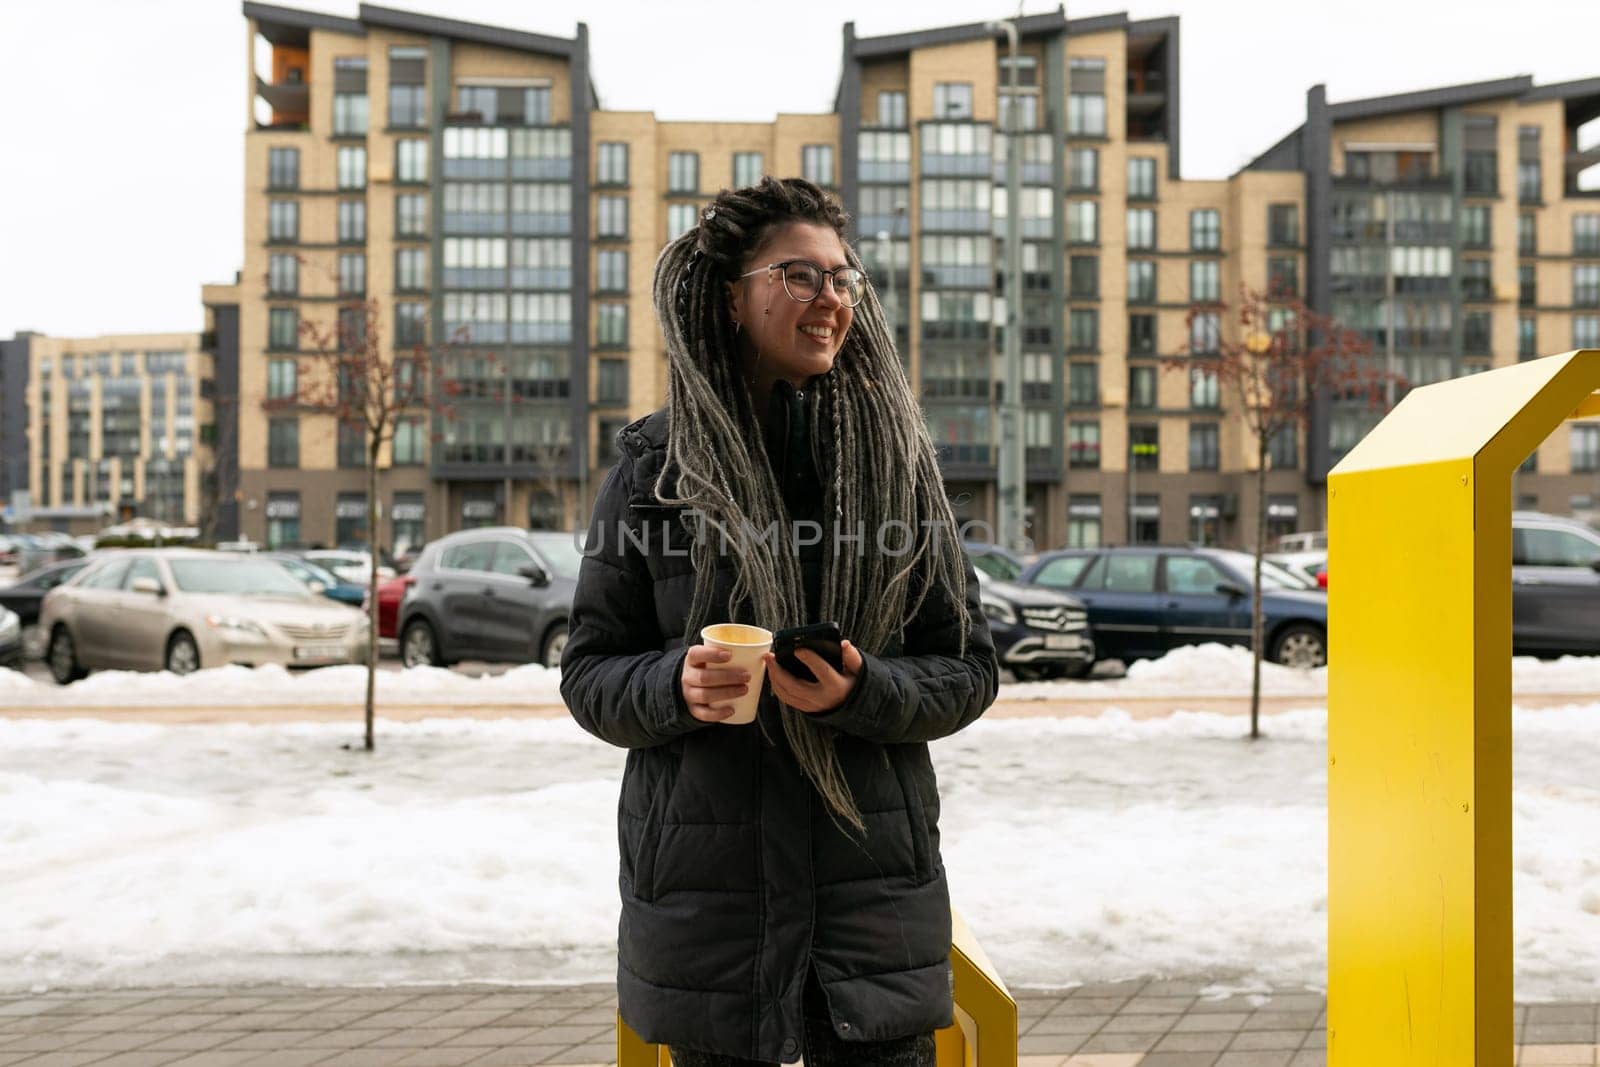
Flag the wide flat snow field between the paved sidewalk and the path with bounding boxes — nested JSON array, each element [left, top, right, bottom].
[[0, 704, 1600, 1000]]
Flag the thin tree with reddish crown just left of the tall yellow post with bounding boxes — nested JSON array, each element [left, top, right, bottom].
[[1162, 279, 1403, 739]]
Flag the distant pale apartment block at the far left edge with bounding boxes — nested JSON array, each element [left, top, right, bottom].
[[0, 333, 213, 533]]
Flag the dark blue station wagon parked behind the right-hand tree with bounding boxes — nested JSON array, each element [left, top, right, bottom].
[[1019, 545, 1328, 667]]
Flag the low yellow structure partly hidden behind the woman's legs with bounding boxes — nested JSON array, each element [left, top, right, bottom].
[[616, 909, 1018, 1067]]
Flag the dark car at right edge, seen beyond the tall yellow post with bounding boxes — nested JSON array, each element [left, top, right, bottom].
[[1510, 512, 1600, 656]]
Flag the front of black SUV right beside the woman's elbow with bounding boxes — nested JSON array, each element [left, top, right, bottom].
[[978, 571, 1094, 681]]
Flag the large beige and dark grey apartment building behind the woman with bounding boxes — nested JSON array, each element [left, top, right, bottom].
[[222, 3, 1600, 559]]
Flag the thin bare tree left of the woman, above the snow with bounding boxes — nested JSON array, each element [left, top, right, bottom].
[[264, 287, 458, 752]]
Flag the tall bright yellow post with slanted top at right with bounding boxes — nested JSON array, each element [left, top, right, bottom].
[[1328, 350, 1600, 1067]]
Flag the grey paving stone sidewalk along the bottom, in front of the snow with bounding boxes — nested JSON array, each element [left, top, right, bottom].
[[0, 981, 1600, 1067]]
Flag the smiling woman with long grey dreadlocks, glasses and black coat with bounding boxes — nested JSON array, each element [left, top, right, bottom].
[[562, 178, 998, 1067]]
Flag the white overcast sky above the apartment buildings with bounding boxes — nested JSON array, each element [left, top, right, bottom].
[[0, 0, 1600, 338]]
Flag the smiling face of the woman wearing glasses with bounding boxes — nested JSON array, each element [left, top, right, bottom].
[[728, 222, 854, 395]]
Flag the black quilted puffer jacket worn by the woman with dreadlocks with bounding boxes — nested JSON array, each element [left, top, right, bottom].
[[562, 395, 998, 1061]]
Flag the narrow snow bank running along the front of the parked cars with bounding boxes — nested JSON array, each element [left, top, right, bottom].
[[0, 645, 1600, 709]]
